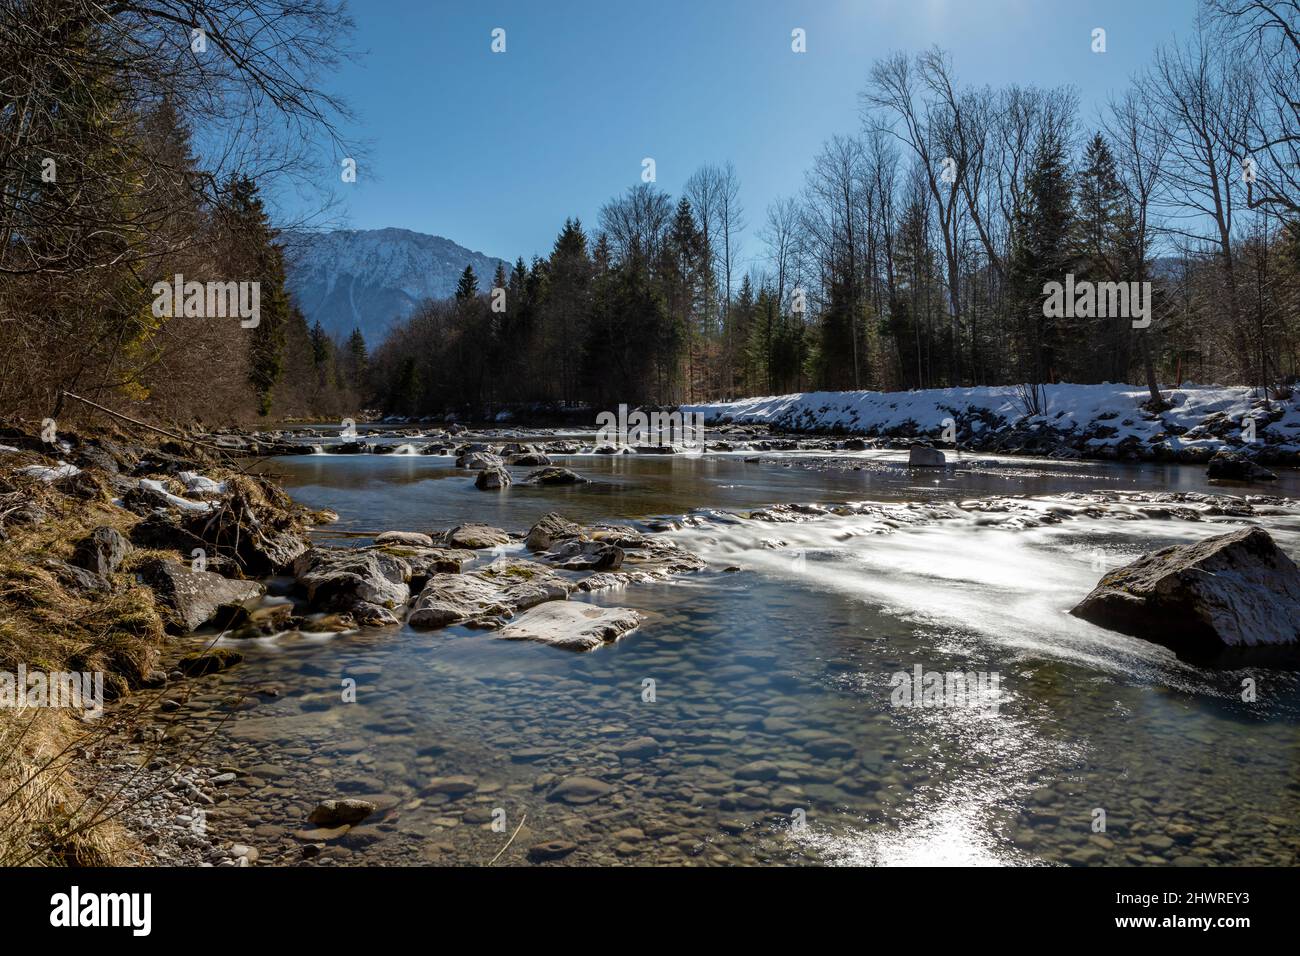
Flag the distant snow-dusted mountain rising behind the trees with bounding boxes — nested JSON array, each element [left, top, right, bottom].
[[283, 229, 510, 349]]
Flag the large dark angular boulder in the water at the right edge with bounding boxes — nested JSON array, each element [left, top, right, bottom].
[[1070, 528, 1300, 663]]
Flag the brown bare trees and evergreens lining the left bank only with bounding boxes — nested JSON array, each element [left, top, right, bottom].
[[0, 0, 363, 423]]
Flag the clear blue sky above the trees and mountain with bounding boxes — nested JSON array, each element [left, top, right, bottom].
[[309, 0, 1196, 267]]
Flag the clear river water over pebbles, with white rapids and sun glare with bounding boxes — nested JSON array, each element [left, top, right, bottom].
[[162, 451, 1300, 865]]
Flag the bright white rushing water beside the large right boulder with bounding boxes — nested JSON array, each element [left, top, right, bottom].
[[675, 498, 1300, 692]]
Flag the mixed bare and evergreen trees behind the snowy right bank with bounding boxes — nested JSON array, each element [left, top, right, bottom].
[[371, 0, 1300, 414]]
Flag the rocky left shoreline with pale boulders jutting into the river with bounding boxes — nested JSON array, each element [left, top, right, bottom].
[[0, 427, 703, 866]]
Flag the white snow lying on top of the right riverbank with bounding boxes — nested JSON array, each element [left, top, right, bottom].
[[681, 384, 1300, 449]]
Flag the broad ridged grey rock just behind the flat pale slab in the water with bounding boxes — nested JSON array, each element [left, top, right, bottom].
[[407, 558, 573, 628]]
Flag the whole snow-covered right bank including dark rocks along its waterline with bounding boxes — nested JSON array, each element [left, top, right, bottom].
[[681, 384, 1300, 464]]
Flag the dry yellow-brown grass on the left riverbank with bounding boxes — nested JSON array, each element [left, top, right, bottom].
[[0, 434, 223, 866]]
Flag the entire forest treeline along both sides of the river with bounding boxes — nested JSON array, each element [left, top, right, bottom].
[[0, 0, 1300, 421]]
